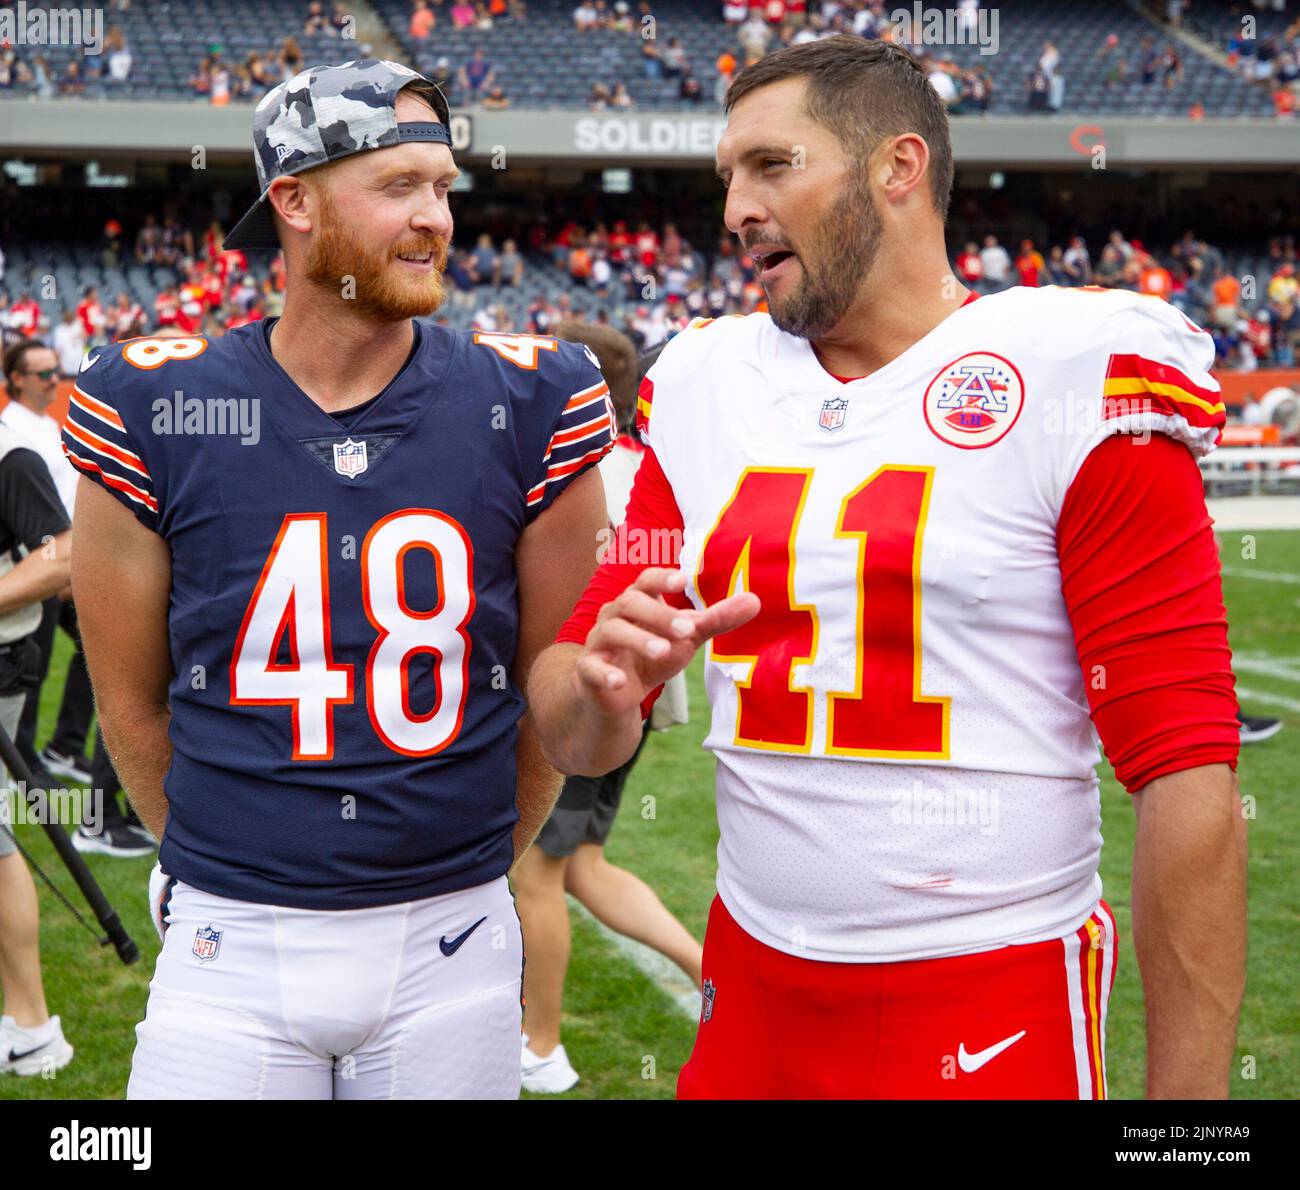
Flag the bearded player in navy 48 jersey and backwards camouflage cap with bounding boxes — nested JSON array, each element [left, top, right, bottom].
[[64, 60, 612, 1099]]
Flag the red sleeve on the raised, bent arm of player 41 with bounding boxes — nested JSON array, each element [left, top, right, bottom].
[[555, 447, 692, 715]]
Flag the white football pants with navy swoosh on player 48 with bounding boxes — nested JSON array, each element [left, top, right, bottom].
[[126, 877, 523, 1099]]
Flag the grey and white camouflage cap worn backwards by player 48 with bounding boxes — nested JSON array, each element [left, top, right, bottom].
[[224, 59, 451, 251]]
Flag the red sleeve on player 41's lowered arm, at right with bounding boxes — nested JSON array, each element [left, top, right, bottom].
[[1057, 434, 1240, 793]]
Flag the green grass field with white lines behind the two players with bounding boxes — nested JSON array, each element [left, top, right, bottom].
[[0, 532, 1300, 1099]]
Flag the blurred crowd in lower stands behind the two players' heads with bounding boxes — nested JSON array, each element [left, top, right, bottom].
[[0, 213, 1300, 375]]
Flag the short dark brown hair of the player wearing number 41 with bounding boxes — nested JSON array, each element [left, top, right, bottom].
[[724, 34, 953, 218]]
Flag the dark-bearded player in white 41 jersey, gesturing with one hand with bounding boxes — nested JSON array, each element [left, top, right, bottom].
[[532, 36, 1245, 1098]]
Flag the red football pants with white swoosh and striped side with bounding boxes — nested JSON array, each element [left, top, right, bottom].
[[677, 897, 1115, 1099]]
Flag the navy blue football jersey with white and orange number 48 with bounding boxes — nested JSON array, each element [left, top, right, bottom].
[[64, 323, 614, 909]]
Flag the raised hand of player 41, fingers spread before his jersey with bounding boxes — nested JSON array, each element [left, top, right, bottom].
[[575, 567, 759, 715]]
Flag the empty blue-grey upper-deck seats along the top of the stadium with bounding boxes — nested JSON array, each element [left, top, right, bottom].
[[0, 0, 1279, 117]]
